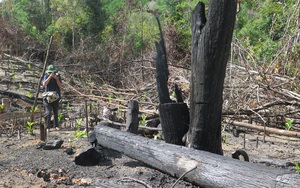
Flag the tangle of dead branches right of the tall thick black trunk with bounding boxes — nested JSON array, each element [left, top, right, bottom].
[[223, 64, 300, 130]]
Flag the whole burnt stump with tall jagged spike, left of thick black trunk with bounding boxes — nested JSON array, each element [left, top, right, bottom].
[[156, 17, 189, 145]]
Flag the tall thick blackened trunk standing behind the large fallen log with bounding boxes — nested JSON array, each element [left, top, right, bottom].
[[186, 0, 237, 154]]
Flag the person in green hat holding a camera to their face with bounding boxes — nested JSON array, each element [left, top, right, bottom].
[[43, 65, 62, 130]]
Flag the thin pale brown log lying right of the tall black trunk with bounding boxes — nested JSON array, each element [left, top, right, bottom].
[[229, 121, 300, 138]]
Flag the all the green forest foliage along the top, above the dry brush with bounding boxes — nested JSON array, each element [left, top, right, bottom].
[[2, 0, 300, 77]]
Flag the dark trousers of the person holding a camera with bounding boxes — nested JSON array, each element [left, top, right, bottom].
[[43, 99, 59, 129]]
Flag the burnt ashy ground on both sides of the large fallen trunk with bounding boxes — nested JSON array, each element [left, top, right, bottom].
[[0, 124, 300, 188]]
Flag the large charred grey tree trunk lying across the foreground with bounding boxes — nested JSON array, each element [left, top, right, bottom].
[[94, 125, 300, 188]]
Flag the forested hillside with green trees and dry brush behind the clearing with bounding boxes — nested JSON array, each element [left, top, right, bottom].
[[0, 0, 300, 109]]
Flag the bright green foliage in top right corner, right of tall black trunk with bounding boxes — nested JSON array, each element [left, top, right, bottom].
[[236, 0, 299, 65]]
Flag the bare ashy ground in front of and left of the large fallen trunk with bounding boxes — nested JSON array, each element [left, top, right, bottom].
[[0, 130, 197, 187]]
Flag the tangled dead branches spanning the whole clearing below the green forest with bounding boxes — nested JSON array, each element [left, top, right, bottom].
[[1, 50, 300, 135]]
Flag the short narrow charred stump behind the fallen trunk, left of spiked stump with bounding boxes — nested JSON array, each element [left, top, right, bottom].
[[125, 100, 139, 134]]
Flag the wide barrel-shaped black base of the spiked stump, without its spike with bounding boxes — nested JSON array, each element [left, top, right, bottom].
[[159, 103, 189, 145]]
